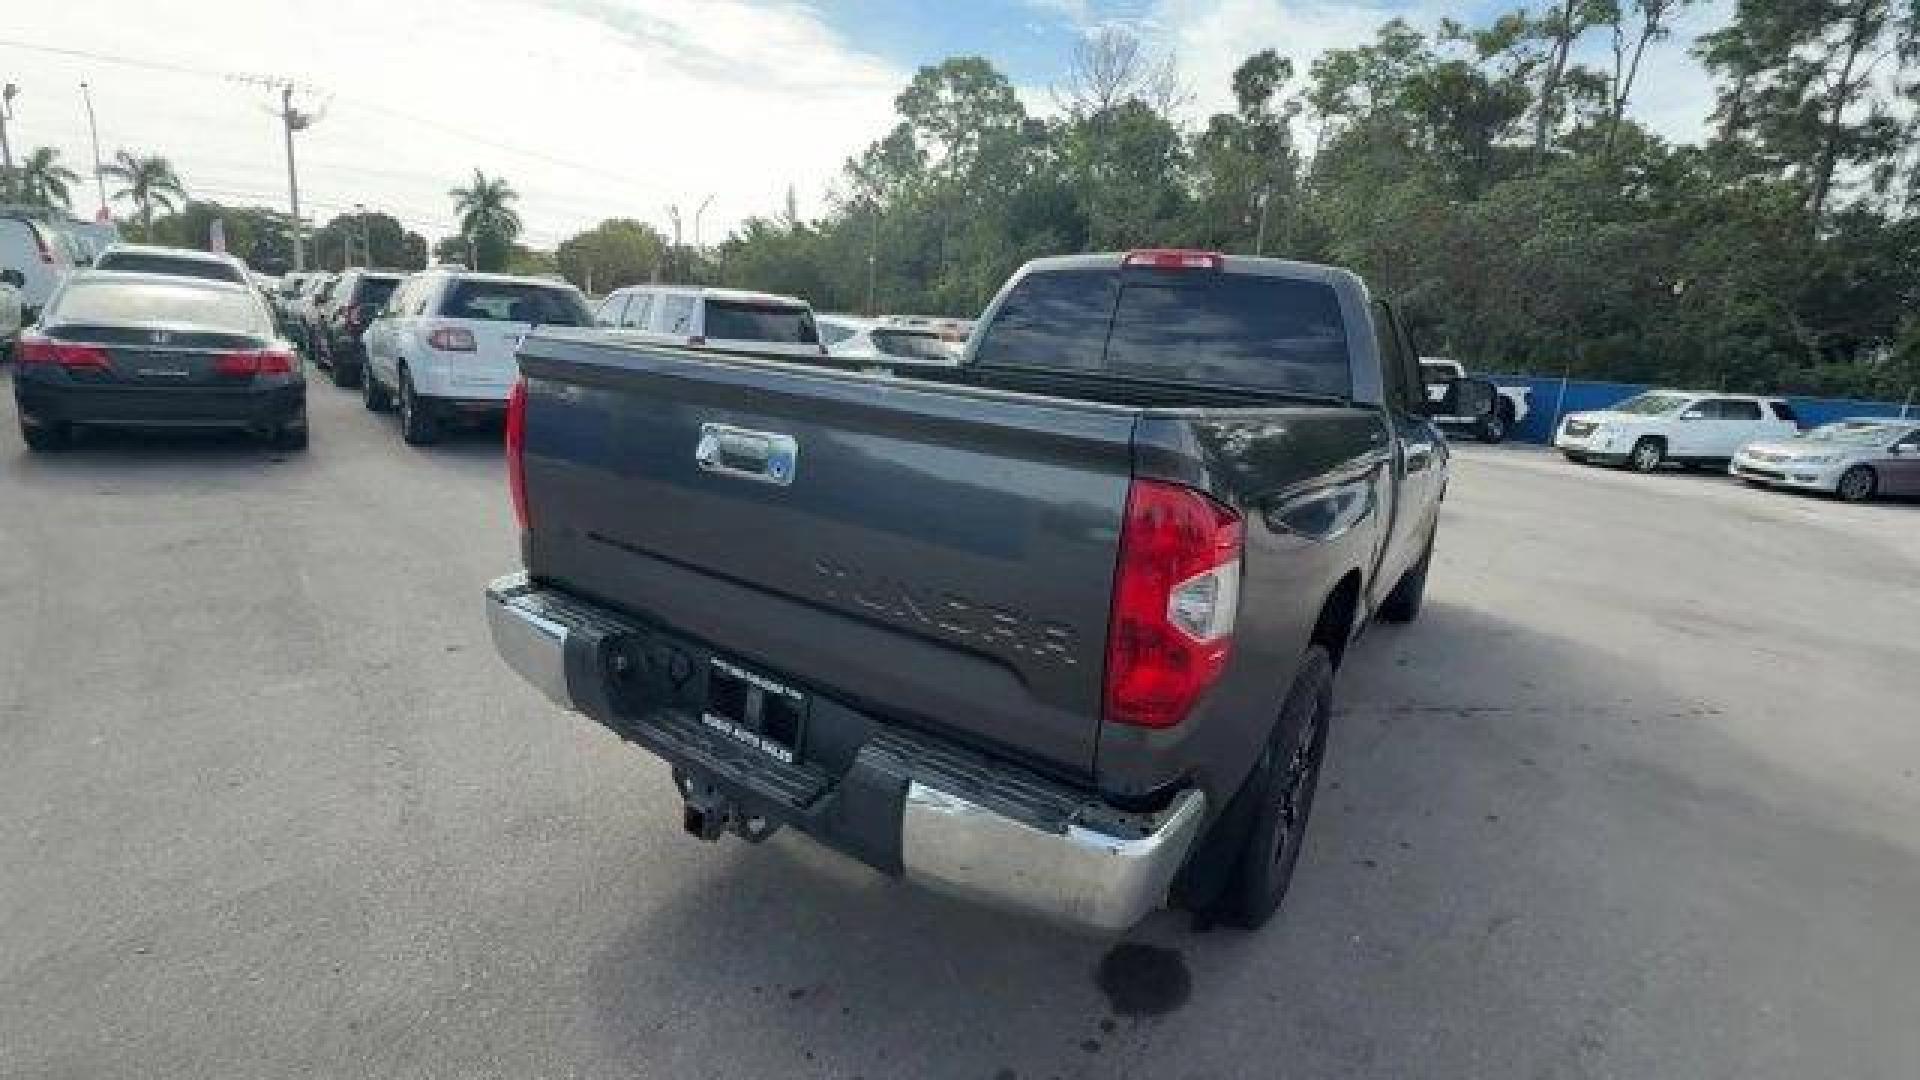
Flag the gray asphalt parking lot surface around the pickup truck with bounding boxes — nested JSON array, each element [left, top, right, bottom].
[[0, 382, 1920, 1080]]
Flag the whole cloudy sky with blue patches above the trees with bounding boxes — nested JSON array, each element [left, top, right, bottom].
[[0, 0, 1730, 248]]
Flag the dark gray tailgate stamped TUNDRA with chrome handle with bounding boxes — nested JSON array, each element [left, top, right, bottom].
[[520, 334, 1135, 776]]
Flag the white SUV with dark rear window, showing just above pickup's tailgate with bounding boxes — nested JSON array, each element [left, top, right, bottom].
[[593, 284, 828, 357]]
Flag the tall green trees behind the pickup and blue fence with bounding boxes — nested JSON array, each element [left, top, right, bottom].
[[706, 0, 1920, 396]]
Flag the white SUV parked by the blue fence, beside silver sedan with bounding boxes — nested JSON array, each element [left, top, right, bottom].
[[1553, 390, 1799, 473]]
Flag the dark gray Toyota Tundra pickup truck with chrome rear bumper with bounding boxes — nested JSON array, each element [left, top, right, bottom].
[[486, 250, 1448, 932]]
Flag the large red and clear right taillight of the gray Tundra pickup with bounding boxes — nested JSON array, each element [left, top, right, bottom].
[[1106, 480, 1246, 728]]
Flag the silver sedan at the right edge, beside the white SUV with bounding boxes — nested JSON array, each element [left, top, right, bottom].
[[1728, 417, 1920, 502]]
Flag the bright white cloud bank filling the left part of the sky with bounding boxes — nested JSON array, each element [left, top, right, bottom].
[[0, 0, 906, 246]]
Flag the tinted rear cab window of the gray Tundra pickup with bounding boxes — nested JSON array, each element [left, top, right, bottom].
[[973, 267, 1352, 398]]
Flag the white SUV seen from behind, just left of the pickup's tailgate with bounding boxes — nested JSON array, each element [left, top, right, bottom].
[[361, 269, 593, 446]]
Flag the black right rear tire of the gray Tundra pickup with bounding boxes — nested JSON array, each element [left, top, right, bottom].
[[1219, 646, 1332, 930]]
